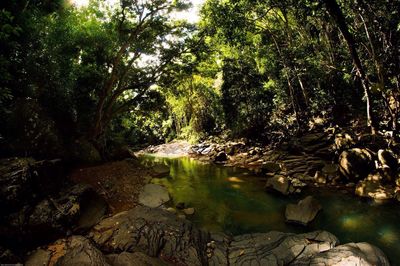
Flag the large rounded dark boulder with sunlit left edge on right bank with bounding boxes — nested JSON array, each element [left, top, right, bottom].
[[339, 148, 374, 180]]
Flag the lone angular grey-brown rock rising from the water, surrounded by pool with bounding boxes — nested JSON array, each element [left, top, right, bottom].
[[285, 196, 322, 225]]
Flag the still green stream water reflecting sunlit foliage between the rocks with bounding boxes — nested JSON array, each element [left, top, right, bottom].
[[142, 156, 400, 265]]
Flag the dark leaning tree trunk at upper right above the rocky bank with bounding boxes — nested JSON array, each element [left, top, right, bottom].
[[324, 0, 376, 135]]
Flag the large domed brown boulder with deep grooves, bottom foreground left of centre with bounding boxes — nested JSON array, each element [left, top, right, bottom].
[[90, 206, 210, 265]]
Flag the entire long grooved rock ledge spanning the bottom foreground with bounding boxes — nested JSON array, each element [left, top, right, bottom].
[[86, 206, 387, 266]]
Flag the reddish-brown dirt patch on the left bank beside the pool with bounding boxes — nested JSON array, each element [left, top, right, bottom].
[[69, 159, 152, 214]]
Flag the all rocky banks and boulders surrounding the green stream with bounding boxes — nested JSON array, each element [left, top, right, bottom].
[[0, 128, 397, 265]]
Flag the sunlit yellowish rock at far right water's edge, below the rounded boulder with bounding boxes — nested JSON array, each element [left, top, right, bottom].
[[355, 180, 394, 200]]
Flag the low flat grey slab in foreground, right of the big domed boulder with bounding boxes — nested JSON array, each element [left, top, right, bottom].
[[228, 231, 338, 265]]
